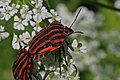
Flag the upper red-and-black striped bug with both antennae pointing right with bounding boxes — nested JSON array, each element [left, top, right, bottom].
[[28, 9, 82, 59]]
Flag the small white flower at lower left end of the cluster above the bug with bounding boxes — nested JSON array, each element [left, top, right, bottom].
[[14, 16, 28, 30]]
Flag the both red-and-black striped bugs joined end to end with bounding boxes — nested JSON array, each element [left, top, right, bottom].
[[13, 9, 83, 80]]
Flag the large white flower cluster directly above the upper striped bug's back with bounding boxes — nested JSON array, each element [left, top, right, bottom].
[[14, 0, 61, 32]]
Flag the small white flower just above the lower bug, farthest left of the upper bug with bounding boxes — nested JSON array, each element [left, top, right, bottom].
[[12, 34, 25, 49]]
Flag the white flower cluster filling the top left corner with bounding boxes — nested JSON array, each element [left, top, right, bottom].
[[0, 0, 20, 21]]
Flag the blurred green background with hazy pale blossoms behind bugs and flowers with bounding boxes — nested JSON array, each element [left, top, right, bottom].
[[0, 0, 120, 80]]
